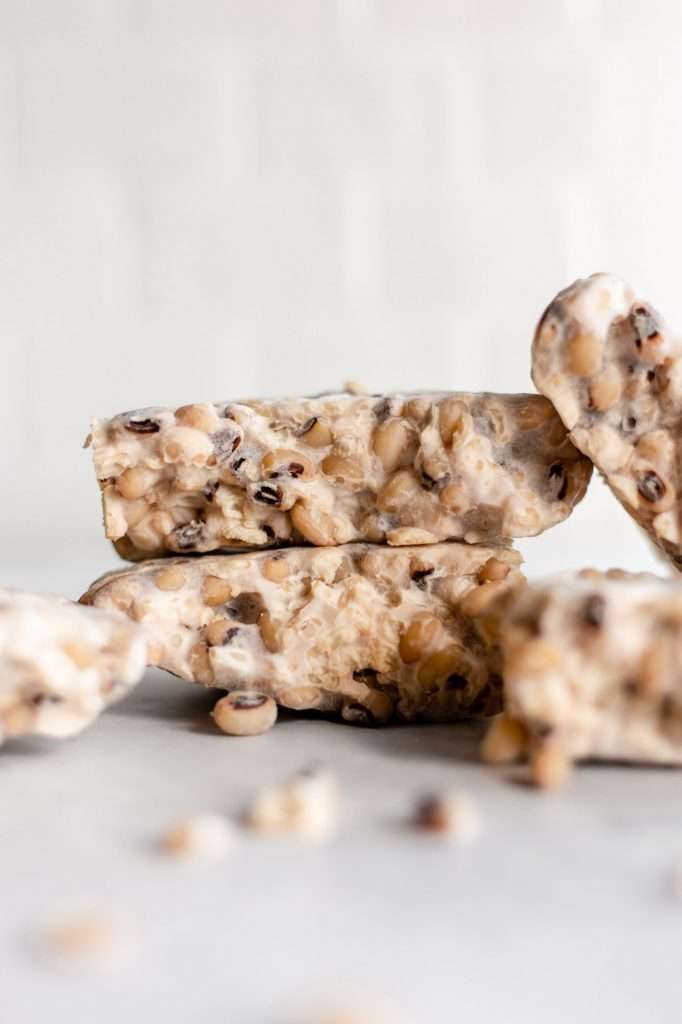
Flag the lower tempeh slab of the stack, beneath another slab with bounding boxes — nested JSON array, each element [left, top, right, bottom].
[[82, 544, 522, 723]]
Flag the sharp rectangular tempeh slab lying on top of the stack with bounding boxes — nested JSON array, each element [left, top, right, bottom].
[[91, 393, 592, 560]]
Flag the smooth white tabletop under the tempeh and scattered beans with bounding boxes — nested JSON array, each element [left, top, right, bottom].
[[0, 540, 682, 1024]]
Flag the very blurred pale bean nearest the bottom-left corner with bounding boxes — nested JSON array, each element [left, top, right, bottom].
[[35, 912, 139, 972]]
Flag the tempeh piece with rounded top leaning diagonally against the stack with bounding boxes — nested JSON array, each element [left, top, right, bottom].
[[532, 273, 682, 568]]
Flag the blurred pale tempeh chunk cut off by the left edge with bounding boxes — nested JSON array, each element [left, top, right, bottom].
[[0, 590, 145, 742]]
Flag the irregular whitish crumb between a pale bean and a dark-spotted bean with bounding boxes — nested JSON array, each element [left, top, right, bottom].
[[246, 766, 339, 841]]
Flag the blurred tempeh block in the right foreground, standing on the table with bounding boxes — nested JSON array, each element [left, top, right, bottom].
[[483, 569, 682, 786]]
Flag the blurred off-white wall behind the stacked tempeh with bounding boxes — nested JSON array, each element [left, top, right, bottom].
[[0, 0, 682, 569]]
